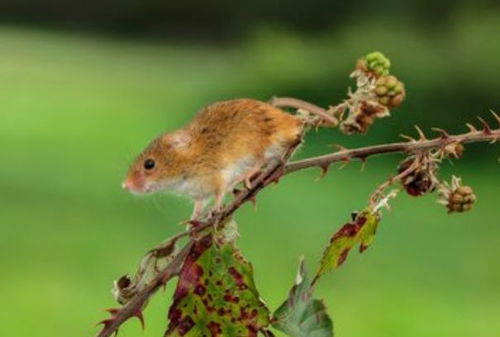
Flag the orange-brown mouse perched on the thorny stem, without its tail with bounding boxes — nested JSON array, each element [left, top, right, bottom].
[[122, 98, 304, 220]]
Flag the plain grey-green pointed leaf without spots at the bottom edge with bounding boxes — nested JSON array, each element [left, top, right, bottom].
[[273, 261, 333, 337]]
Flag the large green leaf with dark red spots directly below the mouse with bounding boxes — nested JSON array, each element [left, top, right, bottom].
[[165, 234, 269, 337]]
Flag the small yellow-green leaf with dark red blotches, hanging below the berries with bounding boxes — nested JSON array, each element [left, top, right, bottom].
[[313, 209, 380, 283]]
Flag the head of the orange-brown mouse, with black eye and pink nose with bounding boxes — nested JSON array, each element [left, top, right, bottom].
[[122, 131, 190, 194]]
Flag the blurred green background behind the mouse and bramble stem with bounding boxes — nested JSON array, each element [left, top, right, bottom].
[[0, 0, 500, 337]]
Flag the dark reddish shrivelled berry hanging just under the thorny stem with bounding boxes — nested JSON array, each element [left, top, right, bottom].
[[398, 157, 436, 197]]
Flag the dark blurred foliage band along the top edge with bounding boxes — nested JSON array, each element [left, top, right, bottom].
[[0, 0, 498, 40]]
